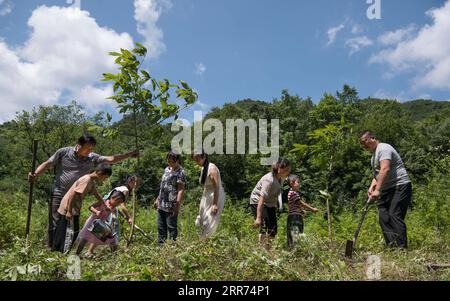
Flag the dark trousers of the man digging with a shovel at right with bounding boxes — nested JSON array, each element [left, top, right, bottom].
[[377, 183, 412, 249]]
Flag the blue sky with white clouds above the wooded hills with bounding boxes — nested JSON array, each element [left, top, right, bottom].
[[0, 0, 450, 122]]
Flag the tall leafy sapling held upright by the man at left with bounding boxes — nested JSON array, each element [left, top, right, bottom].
[[103, 43, 198, 245]]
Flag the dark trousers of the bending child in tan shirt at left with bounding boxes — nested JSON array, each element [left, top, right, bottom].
[[52, 213, 80, 253]]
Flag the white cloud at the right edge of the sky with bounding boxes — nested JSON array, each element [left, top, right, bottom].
[[369, 0, 450, 90]]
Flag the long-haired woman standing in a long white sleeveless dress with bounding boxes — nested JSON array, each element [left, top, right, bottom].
[[192, 152, 225, 238]]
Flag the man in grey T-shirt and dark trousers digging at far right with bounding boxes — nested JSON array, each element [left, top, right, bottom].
[[360, 131, 412, 249]]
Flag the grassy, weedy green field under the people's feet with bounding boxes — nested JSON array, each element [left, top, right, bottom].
[[0, 179, 450, 281]]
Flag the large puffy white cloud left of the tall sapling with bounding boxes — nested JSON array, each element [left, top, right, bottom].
[[0, 6, 133, 122]]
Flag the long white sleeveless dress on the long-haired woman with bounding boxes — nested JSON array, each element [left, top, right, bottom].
[[195, 163, 225, 238]]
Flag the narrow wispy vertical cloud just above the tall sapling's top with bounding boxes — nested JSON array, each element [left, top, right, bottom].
[[134, 0, 172, 59]]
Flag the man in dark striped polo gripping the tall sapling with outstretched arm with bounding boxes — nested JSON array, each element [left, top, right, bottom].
[[28, 134, 139, 249]]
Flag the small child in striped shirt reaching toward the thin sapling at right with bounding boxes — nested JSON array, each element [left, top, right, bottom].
[[286, 175, 318, 249]]
